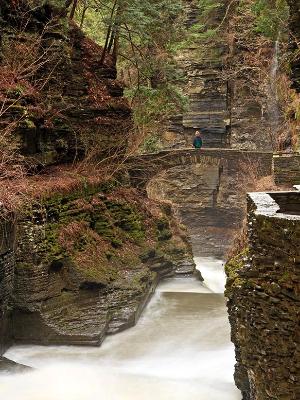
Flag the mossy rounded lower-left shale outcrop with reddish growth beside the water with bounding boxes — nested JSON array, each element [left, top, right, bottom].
[[12, 184, 194, 345]]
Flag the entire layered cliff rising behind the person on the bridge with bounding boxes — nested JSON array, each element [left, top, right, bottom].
[[163, 0, 280, 150]]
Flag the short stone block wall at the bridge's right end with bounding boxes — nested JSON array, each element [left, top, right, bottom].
[[273, 154, 300, 186]]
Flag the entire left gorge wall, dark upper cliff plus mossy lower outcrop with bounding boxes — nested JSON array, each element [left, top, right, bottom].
[[0, 0, 195, 354]]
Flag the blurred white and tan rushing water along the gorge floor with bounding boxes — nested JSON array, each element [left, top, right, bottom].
[[0, 258, 240, 400]]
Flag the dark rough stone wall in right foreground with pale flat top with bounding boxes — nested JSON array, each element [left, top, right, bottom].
[[226, 192, 300, 400]]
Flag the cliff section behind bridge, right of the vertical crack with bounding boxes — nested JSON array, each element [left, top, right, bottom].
[[224, 2, 280, 150]]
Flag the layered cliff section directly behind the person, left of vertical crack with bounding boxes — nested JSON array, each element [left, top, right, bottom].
[[165, 0, 230, 147]]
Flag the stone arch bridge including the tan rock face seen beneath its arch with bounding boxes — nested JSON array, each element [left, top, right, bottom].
[[128, 148, 273, 257]]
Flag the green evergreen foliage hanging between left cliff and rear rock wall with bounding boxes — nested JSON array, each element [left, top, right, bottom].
[[76, 0, 186, 150]]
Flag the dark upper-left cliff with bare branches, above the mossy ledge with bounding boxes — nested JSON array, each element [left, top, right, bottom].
[[0, 0, 131, 165]]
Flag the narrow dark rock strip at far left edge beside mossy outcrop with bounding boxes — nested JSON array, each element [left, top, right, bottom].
[[0, 218, 14, 356]]
